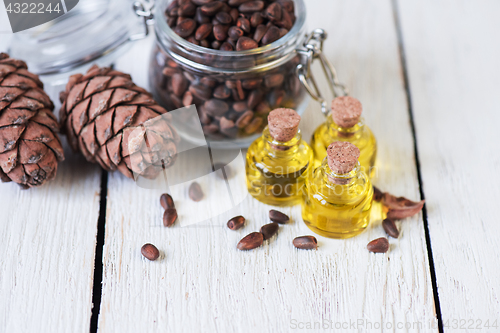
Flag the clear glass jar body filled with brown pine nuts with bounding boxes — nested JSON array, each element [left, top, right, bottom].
[[149, 0, 308, 147]]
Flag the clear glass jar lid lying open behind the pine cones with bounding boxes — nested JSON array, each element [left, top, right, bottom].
[[8, 0, 153, 109]]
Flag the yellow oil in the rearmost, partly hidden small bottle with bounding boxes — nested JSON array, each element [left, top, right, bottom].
[[311, 115, 377, 178]]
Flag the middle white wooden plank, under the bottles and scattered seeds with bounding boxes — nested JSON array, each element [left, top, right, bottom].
[[99, 0, 436, 332]]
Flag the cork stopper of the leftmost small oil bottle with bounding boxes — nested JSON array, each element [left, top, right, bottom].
[[267, 109, 300, 142]]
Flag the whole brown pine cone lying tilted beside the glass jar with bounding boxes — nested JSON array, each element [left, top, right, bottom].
[[60, 66, 180, 178]]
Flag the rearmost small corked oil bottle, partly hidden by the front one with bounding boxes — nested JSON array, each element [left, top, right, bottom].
[[311, 96, 377, 177]]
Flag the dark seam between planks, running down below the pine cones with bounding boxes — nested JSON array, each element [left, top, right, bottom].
[[90, 170, 108, 333]]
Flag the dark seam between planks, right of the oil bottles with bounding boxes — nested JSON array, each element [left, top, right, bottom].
[[391, 0, 444, 333]]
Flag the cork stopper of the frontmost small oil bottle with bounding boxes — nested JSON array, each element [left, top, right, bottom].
[[326, 141, 360, 175]]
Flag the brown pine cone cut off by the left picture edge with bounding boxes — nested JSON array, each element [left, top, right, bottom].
[[0, 53, 64, 188]]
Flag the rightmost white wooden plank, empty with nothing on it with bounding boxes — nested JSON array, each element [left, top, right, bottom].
[[398, 1, 500, 331]]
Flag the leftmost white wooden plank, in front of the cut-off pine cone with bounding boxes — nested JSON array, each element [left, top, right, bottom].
[[0, 40, 101, 333]]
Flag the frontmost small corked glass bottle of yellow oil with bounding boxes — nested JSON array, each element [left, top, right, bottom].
[[302, 141, 373, 238]]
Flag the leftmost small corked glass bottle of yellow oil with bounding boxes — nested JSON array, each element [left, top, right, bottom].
[[246, 109, 313, 206]]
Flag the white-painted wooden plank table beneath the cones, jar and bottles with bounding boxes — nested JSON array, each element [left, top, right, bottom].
[[0, 0, 500, 333]]
